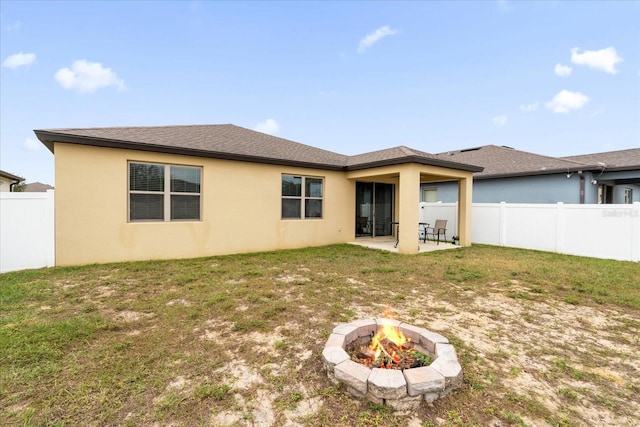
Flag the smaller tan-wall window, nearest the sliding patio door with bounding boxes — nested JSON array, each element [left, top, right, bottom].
[[282, 175, 324, 219]]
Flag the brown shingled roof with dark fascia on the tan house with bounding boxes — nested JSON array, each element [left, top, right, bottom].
[[34, 124, 482, 172]]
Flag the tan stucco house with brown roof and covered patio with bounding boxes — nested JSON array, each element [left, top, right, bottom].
[[34, 124, 482, 265]]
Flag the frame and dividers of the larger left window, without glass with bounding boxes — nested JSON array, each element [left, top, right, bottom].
[[127, 160, 202, 223]]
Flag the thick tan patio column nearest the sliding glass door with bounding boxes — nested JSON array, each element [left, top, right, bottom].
[[398, 165, 420, 254]]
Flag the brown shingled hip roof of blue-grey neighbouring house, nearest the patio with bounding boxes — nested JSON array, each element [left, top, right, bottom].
[[437, 145, 589, 179]]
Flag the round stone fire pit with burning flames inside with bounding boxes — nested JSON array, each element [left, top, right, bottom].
[[322, 317, 462, 411]]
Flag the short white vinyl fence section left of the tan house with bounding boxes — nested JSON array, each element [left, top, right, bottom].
[[0, 190, 55, 273]]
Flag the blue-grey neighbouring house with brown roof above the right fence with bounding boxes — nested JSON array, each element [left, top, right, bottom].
[[421, 145, 640, 204]]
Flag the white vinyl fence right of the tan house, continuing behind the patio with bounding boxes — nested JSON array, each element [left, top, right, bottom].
[[419, 202, 640, 262]]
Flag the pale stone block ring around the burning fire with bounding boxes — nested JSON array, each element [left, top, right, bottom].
[[322, 318, 462, 411]]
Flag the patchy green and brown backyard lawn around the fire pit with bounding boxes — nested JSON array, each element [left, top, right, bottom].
[[0, 245, 640, 426]]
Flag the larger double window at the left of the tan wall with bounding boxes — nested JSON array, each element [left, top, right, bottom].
[[129, 162, 201, 222]]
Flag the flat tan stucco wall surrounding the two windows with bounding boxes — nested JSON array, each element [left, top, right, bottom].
[[55, 143, 355, 266]]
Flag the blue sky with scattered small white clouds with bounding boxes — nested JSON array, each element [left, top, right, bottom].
[[0, 0, 640, 184]]
